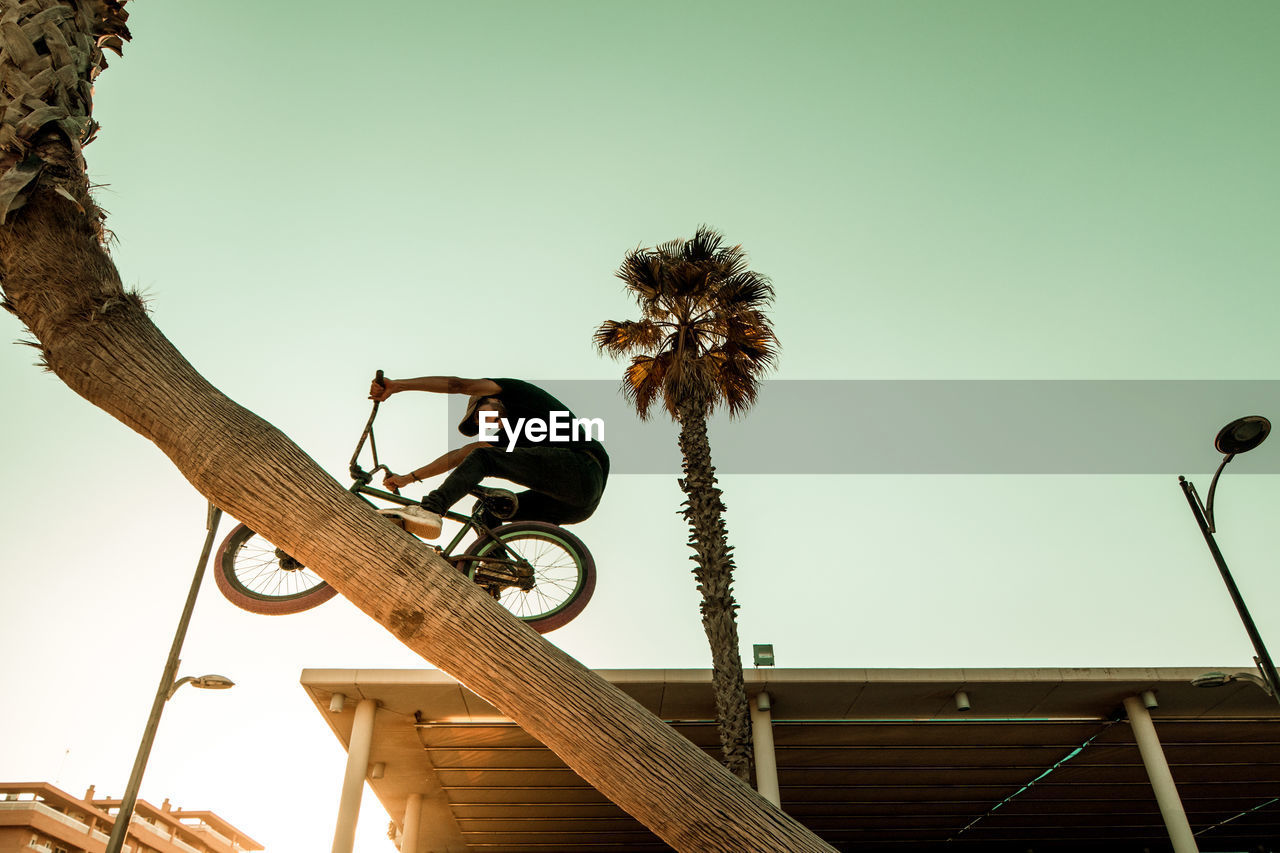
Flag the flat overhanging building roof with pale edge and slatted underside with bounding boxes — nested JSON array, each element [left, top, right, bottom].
[[303, 669, 1280, 853]]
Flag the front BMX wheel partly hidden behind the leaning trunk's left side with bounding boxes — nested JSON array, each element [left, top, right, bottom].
[[214, 524, 338, 616]]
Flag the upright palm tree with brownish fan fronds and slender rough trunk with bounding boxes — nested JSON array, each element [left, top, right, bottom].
[[595, 225, 778, 780]]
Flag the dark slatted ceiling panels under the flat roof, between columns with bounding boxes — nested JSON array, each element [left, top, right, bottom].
[[419, 720, 1280, 853]]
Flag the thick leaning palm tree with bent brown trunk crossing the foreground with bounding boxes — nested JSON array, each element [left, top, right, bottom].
[[0, 6, 831, 853]]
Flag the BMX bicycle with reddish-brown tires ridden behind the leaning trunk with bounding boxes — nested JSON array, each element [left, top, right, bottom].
[[214, 370, 595, 634]]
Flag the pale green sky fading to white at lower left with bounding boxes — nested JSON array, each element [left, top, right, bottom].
[[0, 0, 1280, 853]]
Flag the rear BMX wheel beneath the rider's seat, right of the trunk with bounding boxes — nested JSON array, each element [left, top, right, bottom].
[[465, 521, 595, 634]]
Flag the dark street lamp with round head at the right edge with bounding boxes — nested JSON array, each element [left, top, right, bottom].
[[1178, 415, 1280, 701]]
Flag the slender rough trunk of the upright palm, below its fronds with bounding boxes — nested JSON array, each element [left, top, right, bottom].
[[680, 401, 751, 781]]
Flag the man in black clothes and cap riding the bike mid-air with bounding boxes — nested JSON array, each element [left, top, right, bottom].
[[369, 377, 609, 539]]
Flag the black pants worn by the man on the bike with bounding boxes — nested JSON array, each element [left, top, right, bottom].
[[422, 447, 604, 524]]
